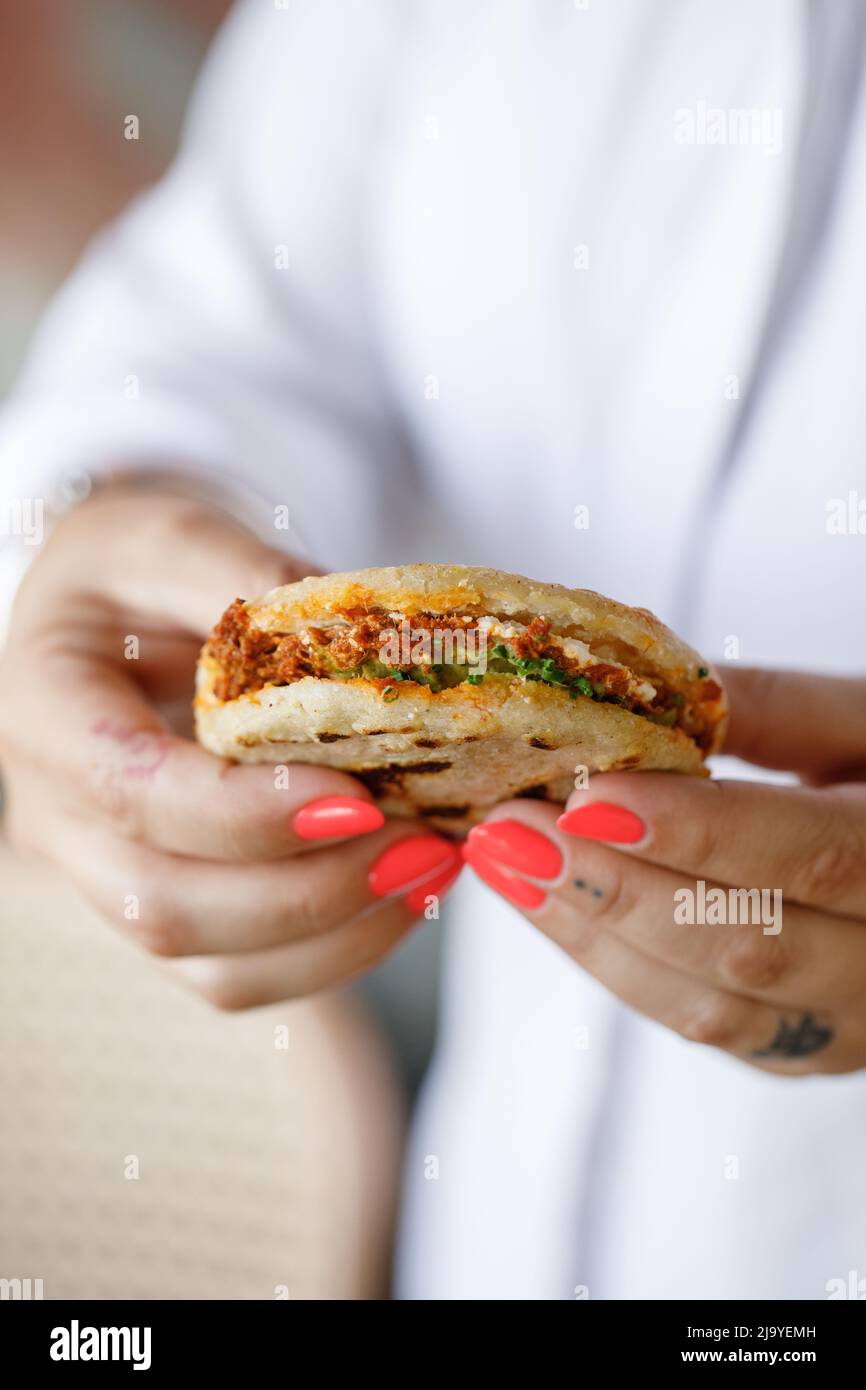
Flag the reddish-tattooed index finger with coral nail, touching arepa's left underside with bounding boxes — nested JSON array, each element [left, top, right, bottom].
[[8, 651, 385, 860]]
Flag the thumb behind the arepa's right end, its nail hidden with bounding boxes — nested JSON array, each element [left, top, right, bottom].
[[723, 666, 866, 783]]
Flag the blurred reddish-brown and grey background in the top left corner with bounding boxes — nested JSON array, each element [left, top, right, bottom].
[[0, 0, 229, 391]]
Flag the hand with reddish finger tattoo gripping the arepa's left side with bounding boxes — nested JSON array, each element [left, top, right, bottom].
[[0, 488, 460, 1008]]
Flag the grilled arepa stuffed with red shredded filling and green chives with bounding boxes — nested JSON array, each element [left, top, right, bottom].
[[195, 564, 727, 834]]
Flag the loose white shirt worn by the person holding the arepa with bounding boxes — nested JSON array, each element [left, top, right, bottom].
[[0, 0, 866, 1298]]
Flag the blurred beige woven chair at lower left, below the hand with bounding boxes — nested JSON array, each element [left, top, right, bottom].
[[0, 845, 400, 1298]]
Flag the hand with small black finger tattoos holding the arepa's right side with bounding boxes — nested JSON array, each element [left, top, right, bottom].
[[466, 669, 866, 1074]]
